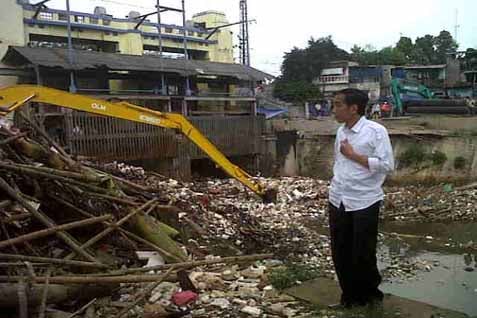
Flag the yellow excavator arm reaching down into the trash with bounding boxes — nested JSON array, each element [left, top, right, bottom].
[[0, 85, 277, 202]]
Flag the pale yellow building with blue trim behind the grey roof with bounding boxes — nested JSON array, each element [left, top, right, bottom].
[[0, 0, 233, 63]]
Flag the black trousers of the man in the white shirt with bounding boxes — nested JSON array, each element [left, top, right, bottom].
[[329, 202, 383, 306]]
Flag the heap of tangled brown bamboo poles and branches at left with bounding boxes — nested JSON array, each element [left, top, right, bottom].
[[0, 120, 272, 317]]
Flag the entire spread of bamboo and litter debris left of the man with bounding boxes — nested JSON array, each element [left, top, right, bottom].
[[0, 119, 333, 318]]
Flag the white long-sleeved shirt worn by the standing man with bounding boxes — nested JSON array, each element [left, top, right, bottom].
[[329, 116, 394, 211]]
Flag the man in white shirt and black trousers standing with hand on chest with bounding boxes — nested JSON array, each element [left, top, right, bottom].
[[329, 89, 394, 307]]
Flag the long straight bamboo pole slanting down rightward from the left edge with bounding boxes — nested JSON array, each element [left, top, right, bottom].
[[0, 177, 98, 263]]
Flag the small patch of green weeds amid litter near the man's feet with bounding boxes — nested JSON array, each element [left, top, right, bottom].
[[269, 264, 320, 290]]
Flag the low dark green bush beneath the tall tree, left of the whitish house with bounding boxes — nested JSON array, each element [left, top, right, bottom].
[[273, 78, 321, 103]]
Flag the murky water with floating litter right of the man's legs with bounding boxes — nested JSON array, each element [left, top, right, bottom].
[[379, 223, 477, 317]]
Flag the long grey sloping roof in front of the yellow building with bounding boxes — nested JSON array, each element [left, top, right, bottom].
[[2, 46, 273, 81]]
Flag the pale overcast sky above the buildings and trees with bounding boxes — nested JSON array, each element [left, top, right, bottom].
[[45, 0, 477, 75]]
